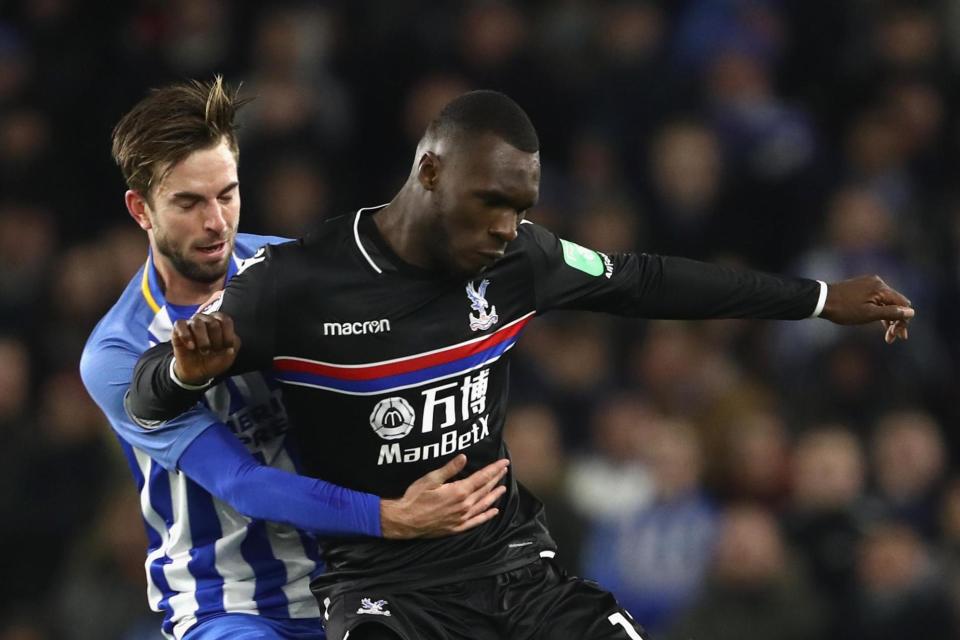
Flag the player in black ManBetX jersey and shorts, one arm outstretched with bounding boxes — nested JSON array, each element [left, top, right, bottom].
[[128, 91, 913, 640]]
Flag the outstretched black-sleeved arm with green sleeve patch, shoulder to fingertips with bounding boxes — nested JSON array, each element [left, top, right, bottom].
[[521, 224, 913, 342]]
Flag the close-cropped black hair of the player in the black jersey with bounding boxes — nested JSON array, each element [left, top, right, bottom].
[[427, 90, 540, 153]]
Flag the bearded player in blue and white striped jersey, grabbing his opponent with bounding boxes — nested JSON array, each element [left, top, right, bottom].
[[80, 78, 507, 640]]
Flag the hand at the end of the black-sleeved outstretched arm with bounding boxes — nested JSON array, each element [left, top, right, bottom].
[[820, 276, 916, 343]]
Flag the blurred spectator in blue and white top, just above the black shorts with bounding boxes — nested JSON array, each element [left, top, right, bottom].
[[583, 417, 717, 634]]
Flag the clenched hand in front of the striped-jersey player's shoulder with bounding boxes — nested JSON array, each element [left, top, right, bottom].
[[170, 311, 240, 384]]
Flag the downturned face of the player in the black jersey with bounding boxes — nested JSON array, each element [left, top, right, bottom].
[[433, 135, 540, 277]]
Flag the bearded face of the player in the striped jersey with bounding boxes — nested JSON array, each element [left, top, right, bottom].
[[147, 141, 240, 283]]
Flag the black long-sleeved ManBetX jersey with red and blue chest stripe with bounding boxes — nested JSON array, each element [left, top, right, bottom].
[[128, 210, 820, 596]]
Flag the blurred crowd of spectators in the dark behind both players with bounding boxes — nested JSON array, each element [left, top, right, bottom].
[[0, 0, 960, 640]]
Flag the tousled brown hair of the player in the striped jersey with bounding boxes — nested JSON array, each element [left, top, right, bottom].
[[112, 76, 250, 201]]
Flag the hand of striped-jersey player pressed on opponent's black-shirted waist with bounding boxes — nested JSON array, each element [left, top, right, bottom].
[[380, 454, 510, 539]]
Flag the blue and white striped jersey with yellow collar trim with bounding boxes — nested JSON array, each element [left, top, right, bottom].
[[80, 234, 322, 639]]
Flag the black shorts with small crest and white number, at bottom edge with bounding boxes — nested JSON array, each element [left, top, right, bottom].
[[321, 560, 649, 640]]
